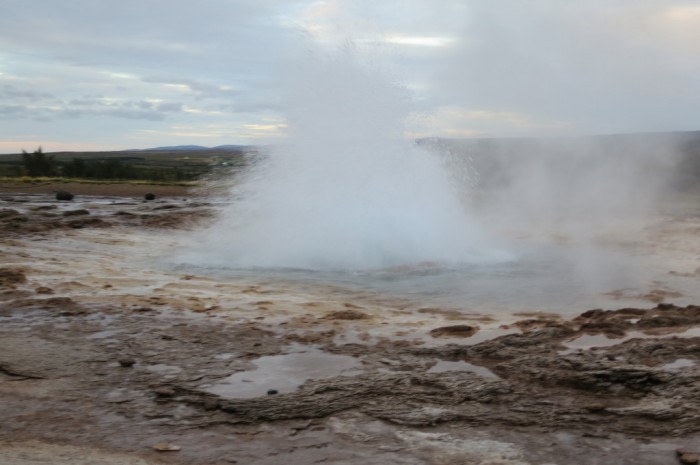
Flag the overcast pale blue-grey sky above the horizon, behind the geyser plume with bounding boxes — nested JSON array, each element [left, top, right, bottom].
[[0, 0, 700, 153]]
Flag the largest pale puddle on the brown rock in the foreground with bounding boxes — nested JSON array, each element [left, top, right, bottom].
[[200, 349, 360, 399]]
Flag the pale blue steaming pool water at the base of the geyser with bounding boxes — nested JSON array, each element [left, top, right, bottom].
[[172, 245, 676, 315]]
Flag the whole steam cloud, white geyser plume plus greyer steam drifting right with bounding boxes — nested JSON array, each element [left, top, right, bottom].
[[187, 47, 674, 275]]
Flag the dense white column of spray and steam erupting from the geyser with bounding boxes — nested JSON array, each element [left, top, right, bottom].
[[190, 50, 499, 270]]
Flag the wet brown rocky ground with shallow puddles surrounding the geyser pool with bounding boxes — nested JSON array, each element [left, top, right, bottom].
[[0, 189, 700, 465]]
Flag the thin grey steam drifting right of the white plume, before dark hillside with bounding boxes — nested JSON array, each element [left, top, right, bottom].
[[434, 134, 679, 244]]
